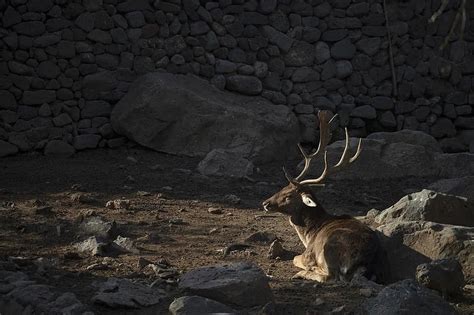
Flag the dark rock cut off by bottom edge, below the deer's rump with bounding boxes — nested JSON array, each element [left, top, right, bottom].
[[365, 279, 456, 315]]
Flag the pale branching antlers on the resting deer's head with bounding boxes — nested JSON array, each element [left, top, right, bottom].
[[283, 111, 362, 185]]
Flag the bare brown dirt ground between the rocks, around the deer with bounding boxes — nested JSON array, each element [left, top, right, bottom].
[[0, 147, 474, 314]]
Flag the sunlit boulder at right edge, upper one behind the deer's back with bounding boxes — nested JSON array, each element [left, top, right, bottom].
[[375, 189, 474, 227]]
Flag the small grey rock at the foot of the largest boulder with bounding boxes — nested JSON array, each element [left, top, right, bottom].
[[197, 149, 254, 178]]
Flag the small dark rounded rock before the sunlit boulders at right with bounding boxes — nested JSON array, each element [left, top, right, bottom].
[[416, 258, 465, 298]]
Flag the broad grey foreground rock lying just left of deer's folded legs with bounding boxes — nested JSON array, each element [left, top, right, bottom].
[[179, 262, 273, 307]]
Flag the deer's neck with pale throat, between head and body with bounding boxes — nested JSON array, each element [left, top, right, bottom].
[[290, 205, 333, 248]]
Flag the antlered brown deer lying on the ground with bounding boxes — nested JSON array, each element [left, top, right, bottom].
[[262, 111, 386, 282]]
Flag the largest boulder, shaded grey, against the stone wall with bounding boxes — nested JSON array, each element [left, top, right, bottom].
[[111, 73, 299, 162]]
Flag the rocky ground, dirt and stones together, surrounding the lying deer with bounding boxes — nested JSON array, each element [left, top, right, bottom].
[[0, 134, 474, 314]]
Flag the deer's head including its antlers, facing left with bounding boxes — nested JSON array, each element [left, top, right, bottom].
[[262, 111, 362, 216]]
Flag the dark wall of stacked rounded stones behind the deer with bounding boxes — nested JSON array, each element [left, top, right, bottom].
[[0, 0, 474, 156]]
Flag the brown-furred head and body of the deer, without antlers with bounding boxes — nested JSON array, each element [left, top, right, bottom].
[[263, 183, 385, 282]]
